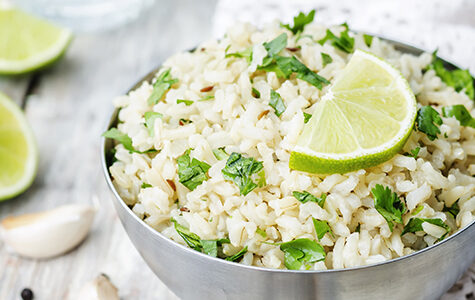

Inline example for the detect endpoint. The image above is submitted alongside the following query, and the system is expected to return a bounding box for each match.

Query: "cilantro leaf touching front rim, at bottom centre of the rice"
[280,239,326,270]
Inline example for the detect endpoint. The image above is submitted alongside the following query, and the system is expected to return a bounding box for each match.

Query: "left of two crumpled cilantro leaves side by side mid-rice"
[177,149,211,191]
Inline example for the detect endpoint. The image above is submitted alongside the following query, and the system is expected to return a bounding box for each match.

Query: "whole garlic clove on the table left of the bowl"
[0,204,96,258]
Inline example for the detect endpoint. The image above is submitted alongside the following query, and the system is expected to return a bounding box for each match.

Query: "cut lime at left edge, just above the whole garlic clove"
[0,93,38,200]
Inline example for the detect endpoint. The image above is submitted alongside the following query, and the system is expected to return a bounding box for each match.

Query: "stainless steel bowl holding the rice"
[101,39,475,300]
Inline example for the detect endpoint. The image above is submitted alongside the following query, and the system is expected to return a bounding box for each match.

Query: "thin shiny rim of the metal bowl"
[100,31,475,275]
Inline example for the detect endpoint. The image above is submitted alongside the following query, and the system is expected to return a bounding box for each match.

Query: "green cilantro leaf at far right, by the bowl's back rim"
[428,50,475,100]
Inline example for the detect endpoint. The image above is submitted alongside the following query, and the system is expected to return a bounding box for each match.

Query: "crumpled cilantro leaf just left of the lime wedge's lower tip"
[221,152,263,196]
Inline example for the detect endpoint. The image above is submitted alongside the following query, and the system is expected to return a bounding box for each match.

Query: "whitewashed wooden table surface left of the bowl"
[0,0,215,300]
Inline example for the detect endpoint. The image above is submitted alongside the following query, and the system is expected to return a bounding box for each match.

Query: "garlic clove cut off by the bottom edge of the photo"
[77,274,119,300]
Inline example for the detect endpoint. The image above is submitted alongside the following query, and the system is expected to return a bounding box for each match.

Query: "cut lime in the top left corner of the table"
[0,9,72,74]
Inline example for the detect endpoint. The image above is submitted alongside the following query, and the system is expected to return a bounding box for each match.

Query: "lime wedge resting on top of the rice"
[289,50,417,174]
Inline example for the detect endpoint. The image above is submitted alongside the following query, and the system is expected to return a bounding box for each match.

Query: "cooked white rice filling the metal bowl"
[110,22,475,270]
